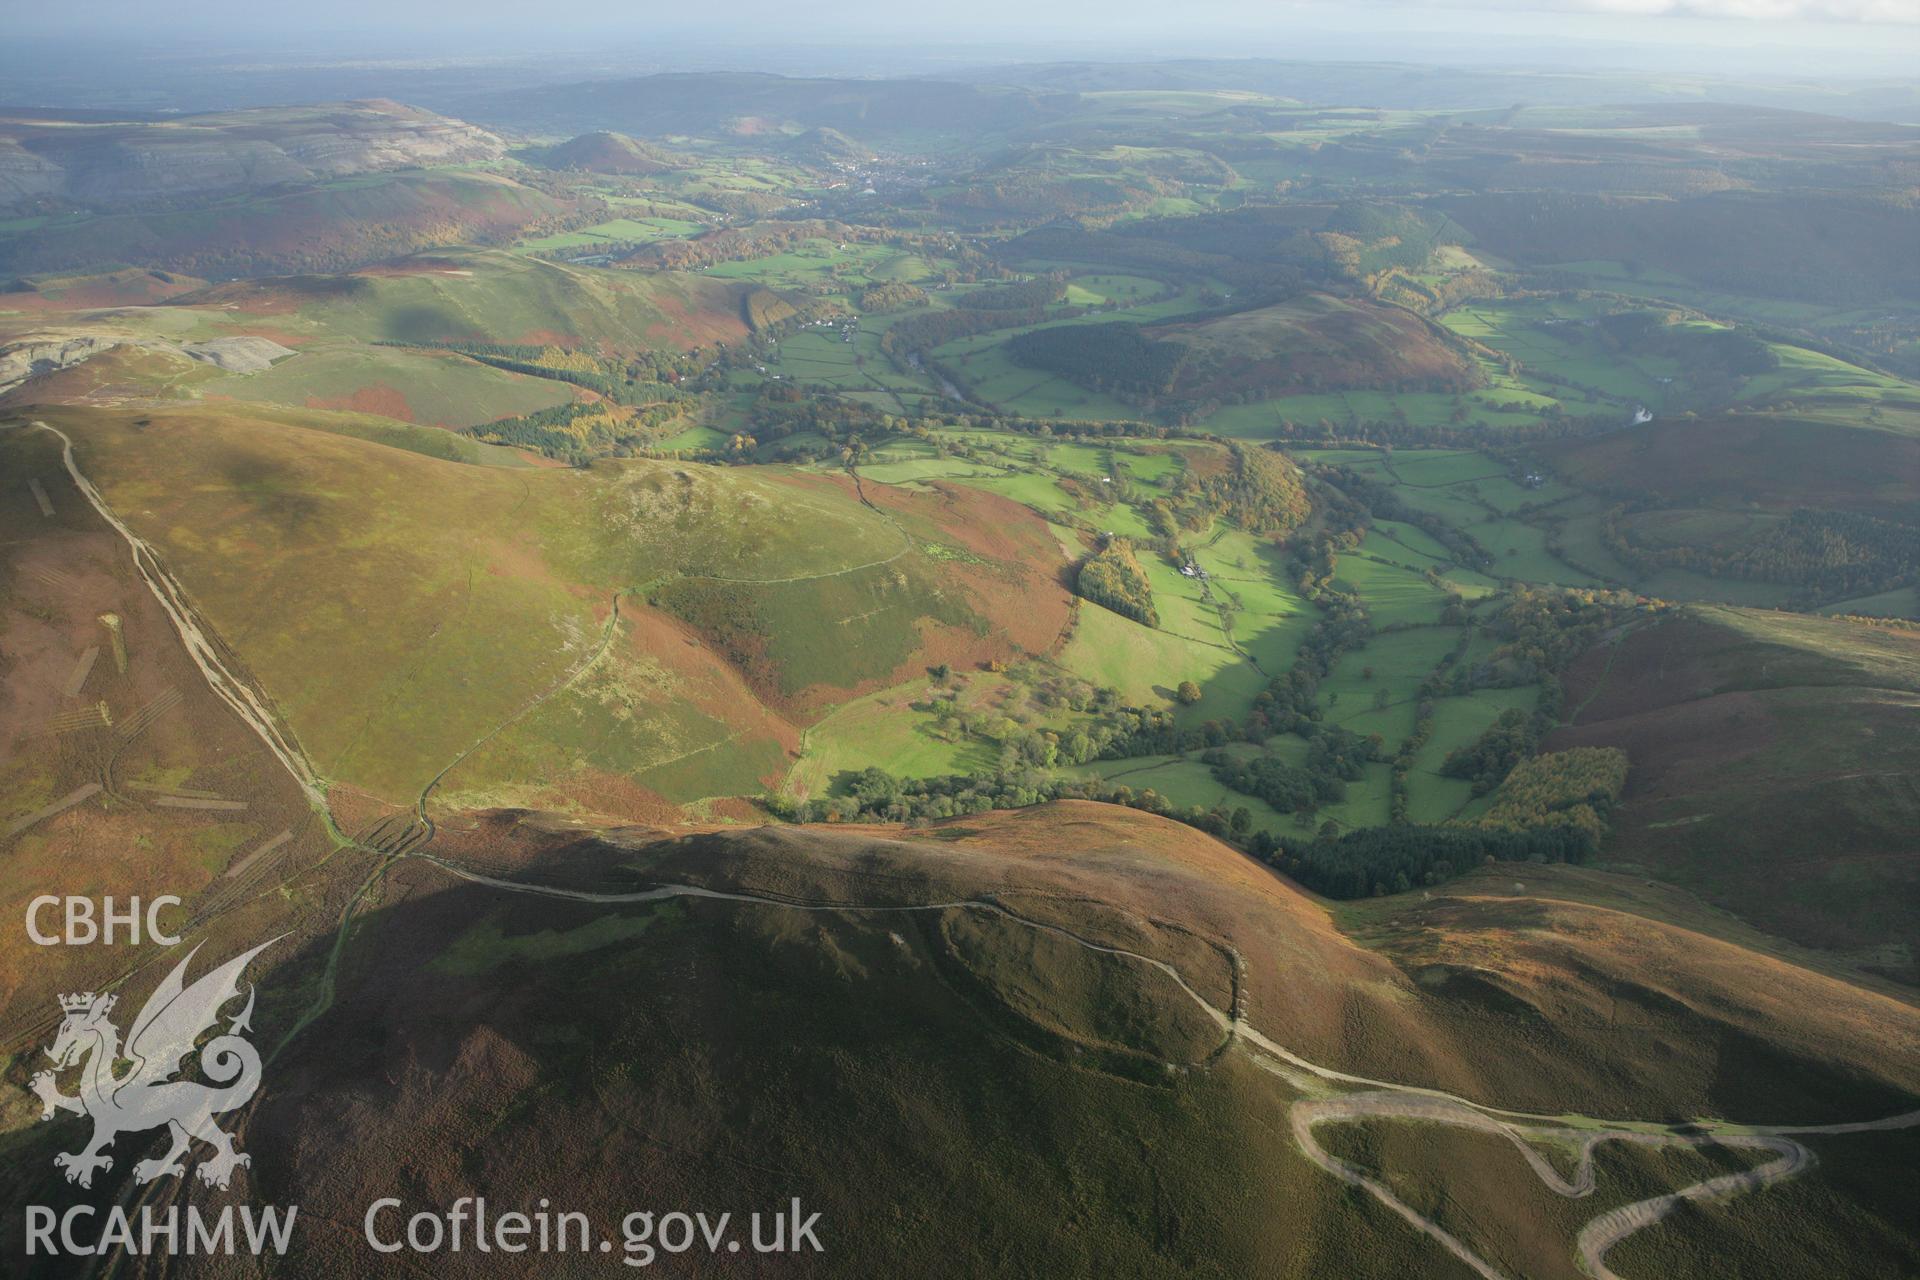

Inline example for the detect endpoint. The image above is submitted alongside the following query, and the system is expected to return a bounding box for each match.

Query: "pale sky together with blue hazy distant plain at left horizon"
[0,0,1920,109]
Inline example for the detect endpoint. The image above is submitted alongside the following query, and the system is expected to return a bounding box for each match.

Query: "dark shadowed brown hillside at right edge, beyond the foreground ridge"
[1549,608,1920,981]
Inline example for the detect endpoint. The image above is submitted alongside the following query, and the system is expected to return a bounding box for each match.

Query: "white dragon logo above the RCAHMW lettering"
[29,938,278,1190]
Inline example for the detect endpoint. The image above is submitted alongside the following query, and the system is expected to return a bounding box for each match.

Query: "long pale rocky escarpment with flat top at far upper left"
[0,100,505,209]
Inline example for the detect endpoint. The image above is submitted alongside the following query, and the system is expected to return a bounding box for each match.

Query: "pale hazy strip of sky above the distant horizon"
[0,0,1920,79]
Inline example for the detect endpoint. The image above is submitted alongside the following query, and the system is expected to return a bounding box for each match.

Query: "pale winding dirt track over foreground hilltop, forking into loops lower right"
[428,854,1920,1280]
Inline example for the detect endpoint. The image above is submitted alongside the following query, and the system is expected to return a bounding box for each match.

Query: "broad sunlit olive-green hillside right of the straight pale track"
[46,407,1066,817]
